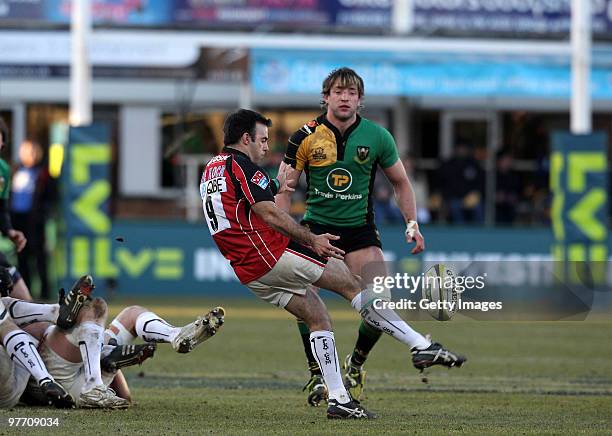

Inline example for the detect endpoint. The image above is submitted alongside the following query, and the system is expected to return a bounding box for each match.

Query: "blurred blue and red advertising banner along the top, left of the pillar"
[0,0,391,29]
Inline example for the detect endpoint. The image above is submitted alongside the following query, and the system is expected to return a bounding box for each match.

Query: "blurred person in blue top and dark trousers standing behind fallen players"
[11,141,56,300]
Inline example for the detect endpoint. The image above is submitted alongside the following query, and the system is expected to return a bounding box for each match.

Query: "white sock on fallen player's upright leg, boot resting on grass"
[73,321,104,392]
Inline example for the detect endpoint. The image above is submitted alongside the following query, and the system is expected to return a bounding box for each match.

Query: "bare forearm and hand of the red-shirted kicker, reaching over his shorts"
[252,201,344,259]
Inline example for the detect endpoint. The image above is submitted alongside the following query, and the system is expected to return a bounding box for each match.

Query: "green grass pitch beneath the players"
[0,297,612,435]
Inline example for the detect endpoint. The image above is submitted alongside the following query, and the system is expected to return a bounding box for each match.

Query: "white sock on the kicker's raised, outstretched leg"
[351,290,431,350]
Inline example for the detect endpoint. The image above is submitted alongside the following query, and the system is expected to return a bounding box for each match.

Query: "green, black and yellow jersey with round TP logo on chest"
[285,114,399,227]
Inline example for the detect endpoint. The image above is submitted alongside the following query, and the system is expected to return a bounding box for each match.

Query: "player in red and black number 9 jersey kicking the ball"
[200,109,465,419]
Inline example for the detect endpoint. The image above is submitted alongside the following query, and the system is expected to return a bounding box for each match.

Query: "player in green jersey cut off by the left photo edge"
[0,118,32,301]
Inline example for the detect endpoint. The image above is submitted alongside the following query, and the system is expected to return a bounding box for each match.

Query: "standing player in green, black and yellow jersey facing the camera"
[276,68,459,406]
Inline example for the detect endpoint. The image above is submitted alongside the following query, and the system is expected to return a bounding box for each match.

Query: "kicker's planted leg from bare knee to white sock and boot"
[285,289,376,419]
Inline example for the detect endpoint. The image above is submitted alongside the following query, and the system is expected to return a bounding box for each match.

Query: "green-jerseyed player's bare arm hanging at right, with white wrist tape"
[383,160,425,254]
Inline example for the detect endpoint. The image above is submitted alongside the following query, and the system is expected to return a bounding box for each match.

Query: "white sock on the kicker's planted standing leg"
[310,330,350,404]
